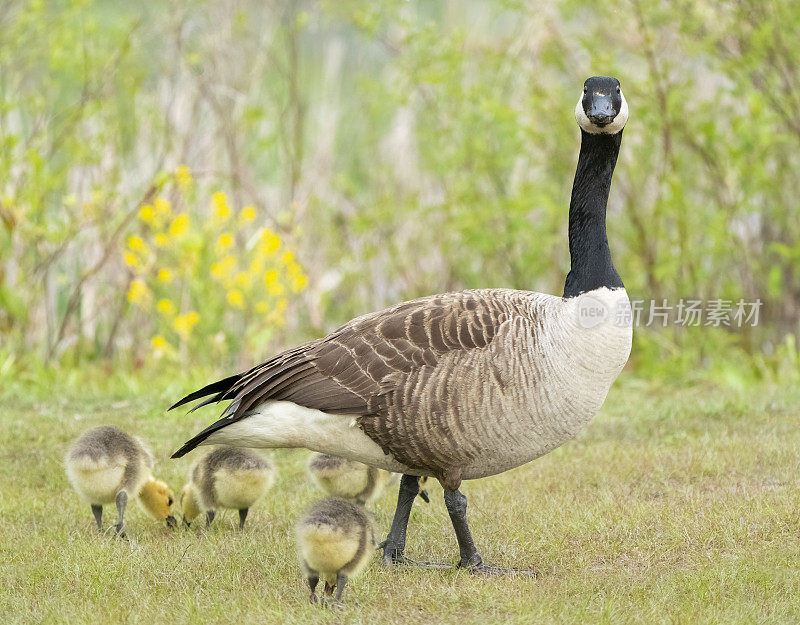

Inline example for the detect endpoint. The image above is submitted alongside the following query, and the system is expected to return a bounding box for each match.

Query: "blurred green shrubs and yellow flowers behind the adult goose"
[0,0,800,386]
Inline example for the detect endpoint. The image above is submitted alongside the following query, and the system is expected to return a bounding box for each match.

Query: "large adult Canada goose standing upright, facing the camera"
[172,77,633,572]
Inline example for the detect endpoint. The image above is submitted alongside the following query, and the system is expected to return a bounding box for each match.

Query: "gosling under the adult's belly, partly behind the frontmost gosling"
[308,454,392,505]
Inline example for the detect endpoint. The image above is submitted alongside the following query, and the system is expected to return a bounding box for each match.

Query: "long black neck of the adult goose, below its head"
[564,129,623,297]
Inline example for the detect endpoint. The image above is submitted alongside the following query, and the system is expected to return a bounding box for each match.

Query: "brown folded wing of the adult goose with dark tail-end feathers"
[176,290,521,453]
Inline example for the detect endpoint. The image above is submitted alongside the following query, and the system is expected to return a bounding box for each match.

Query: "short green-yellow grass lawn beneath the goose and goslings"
[0,372,800,625]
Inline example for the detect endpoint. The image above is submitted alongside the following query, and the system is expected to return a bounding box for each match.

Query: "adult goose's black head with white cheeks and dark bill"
[575,76,628,135]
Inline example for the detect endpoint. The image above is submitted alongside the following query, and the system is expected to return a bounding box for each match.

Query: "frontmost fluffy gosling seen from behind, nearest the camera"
[295,498,375,603]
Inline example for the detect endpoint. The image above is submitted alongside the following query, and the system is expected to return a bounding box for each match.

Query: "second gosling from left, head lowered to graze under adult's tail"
[180,447,275,530]
